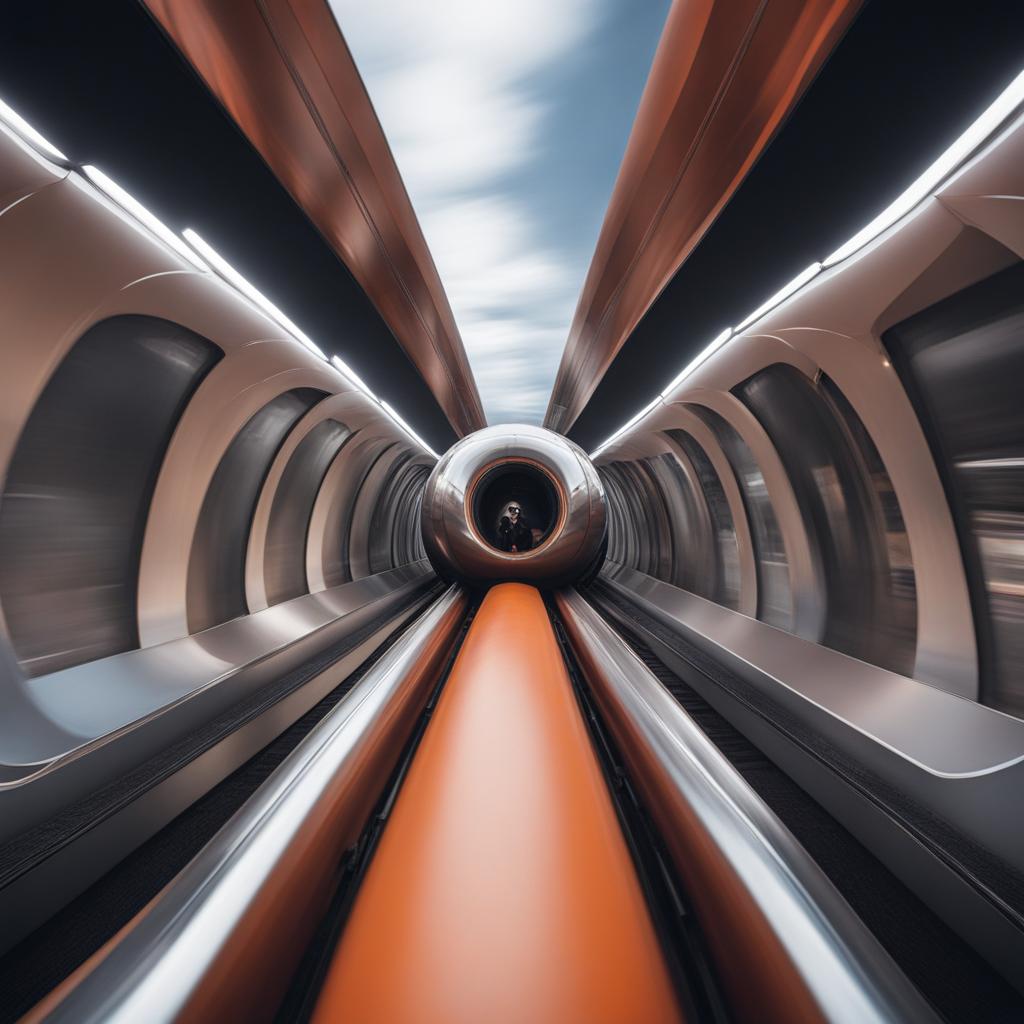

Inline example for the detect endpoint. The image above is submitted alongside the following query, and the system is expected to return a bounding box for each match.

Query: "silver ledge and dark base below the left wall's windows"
[0,562,436,951]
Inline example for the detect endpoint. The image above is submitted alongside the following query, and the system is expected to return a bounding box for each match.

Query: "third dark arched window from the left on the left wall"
[263,420,354,605]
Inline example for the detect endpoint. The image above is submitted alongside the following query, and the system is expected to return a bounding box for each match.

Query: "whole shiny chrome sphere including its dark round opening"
[422,423,606,587]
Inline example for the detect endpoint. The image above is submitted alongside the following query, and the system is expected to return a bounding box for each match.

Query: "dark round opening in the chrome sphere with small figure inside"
[472,460,561,554]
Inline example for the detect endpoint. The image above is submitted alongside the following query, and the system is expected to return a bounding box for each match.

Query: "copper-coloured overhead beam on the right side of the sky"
[544,0,860,433]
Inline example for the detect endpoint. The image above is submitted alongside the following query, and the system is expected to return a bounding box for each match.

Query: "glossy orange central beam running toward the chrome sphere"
[313,584,682,1024]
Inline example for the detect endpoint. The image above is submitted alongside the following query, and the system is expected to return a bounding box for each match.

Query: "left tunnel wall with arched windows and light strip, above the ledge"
[0,128,434,678]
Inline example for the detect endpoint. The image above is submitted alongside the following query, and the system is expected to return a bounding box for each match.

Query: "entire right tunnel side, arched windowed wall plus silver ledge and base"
[594,97,1024,981]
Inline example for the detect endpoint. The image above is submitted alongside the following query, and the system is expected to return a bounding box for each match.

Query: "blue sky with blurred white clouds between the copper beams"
[330,0,670,424]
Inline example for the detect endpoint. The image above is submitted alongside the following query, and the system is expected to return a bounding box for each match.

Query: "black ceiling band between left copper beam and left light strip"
[0,0,456,452]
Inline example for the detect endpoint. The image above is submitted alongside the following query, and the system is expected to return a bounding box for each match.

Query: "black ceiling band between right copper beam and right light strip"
[569,0,1024,451]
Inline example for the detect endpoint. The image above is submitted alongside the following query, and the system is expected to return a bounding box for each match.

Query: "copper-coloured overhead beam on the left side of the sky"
[146,0,486,435]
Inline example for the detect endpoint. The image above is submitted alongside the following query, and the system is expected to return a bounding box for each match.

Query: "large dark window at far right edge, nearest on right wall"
[885,263,1024,716]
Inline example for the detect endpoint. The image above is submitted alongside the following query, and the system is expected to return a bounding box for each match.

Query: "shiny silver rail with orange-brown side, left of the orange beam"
[28,587,465,1024]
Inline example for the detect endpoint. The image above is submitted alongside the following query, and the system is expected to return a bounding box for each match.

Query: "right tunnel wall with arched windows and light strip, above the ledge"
[594,103,1024,716]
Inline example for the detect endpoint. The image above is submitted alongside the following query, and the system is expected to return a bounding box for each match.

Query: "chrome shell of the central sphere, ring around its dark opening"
[422,424,605,585]
